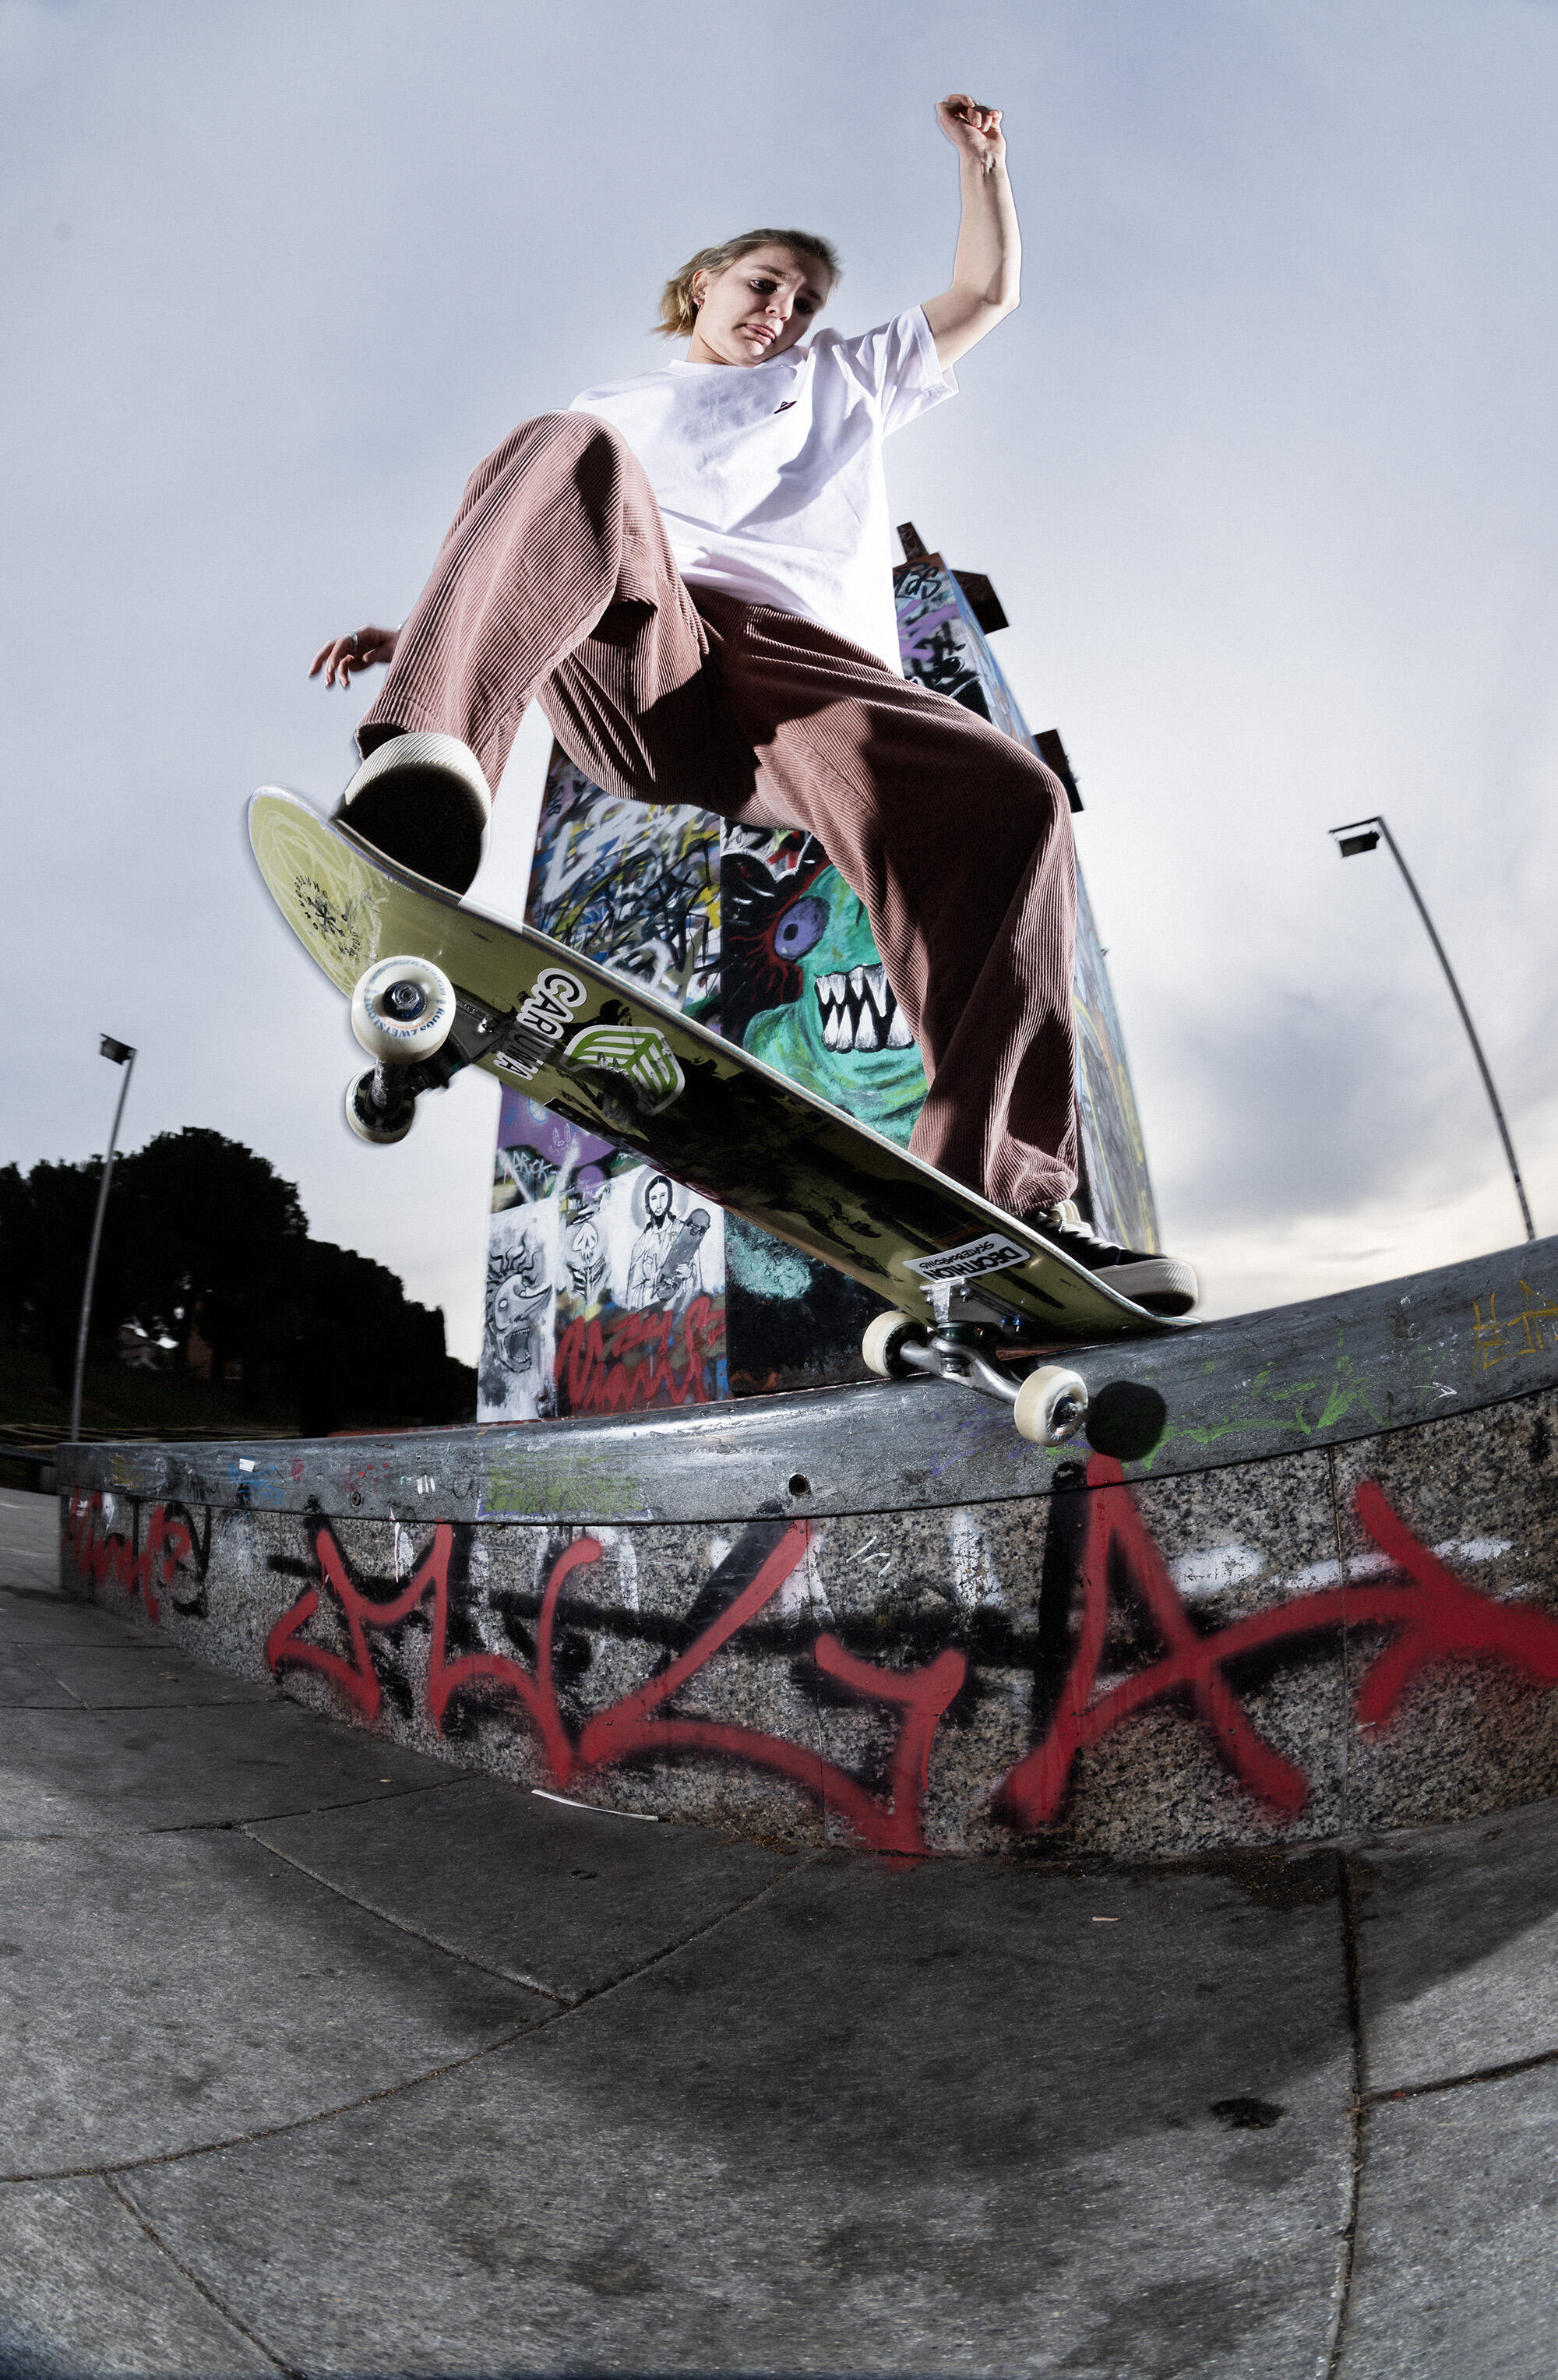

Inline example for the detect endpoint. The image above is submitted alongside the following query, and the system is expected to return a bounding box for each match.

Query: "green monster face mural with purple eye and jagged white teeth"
[721,828,925,1144]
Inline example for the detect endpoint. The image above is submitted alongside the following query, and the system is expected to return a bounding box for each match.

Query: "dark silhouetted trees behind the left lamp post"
[0,1126,476,1435]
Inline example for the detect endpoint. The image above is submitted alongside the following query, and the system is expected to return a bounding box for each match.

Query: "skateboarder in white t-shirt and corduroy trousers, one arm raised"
[309,93,1197,1311]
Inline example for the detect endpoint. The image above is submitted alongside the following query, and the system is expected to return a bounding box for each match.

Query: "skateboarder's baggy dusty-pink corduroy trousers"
[359,414,1077,1214]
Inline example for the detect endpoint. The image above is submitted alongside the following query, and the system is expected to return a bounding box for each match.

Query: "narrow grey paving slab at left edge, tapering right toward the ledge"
[0,1699,461,1837]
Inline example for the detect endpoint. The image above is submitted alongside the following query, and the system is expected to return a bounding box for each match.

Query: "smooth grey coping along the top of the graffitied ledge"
[57,1238,1558,1523]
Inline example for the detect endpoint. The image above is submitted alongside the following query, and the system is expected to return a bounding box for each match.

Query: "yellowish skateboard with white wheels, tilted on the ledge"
[250,785,1183,1444]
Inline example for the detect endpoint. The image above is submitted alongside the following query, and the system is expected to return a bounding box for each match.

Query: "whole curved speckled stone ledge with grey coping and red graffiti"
[51,1240,1558,1856]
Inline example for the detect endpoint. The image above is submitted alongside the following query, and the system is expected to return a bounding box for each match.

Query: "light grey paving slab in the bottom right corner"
[1339,2066,1558,2380]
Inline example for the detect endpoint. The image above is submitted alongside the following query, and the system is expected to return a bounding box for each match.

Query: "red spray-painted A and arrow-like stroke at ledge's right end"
[999,1454,1558,1828]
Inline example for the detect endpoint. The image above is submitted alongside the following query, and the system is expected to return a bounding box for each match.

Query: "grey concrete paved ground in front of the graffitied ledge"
[0,1492,1558,2380]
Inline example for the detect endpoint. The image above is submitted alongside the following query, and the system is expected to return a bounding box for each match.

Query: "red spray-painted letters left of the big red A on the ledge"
[264,1521,968,1852]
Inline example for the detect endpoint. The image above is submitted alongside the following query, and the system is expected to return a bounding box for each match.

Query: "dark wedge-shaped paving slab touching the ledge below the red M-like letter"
[250,1778,818,2001]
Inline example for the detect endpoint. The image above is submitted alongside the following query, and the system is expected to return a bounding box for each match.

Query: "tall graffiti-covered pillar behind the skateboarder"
[481,528,1158,1421]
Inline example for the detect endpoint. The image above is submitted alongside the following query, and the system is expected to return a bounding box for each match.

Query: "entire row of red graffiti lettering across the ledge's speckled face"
[94,1454,1558,1852]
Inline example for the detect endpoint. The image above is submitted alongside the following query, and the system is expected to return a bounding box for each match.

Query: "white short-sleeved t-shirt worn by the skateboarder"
[569,305,959,674]
